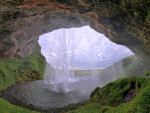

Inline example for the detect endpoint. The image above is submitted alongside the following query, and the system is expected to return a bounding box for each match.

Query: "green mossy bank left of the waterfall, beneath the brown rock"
[0,54,46,91]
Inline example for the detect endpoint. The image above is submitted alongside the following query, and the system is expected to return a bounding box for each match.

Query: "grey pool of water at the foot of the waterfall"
[4,76,103,109]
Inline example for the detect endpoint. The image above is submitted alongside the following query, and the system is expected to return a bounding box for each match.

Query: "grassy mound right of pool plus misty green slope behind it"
[71,55,150,113]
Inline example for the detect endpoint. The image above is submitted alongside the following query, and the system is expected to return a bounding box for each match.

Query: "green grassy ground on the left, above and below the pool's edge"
[0,54,45,113]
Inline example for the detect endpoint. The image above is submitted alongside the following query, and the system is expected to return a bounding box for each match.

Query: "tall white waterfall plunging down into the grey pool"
[44,29,75,92]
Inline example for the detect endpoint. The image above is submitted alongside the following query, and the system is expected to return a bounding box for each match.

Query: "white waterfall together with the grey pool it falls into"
[2,26,133,109]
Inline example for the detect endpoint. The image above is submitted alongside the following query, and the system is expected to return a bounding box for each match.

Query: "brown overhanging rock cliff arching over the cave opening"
[0,0,150,61]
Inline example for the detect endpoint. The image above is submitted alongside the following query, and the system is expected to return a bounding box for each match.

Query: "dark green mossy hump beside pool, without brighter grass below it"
[91,77,150,106]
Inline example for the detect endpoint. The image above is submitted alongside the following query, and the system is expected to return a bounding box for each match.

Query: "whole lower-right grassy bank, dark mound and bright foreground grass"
[70,77,150,113]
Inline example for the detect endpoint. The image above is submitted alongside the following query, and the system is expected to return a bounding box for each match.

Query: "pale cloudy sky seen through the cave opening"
[38,26,133,69]
